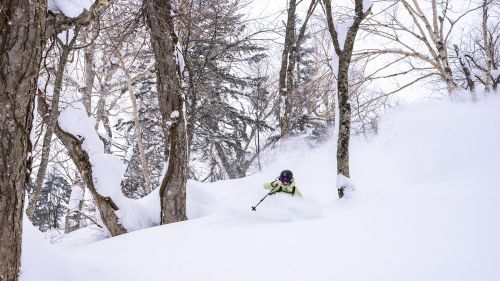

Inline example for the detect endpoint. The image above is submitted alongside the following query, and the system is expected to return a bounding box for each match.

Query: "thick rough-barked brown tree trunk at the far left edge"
[0,0,47,281]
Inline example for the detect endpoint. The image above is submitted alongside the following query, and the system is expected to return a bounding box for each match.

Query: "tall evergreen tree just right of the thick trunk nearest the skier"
[180,0,265,180]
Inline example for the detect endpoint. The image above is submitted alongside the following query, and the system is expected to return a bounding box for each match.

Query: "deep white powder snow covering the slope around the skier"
[21,95,500,281]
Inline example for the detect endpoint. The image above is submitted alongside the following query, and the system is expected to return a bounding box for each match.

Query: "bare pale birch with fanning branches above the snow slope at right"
[356,0,489,96]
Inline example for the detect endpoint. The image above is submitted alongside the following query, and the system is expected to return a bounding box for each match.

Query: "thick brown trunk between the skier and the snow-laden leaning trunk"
[144,0,188,224]
